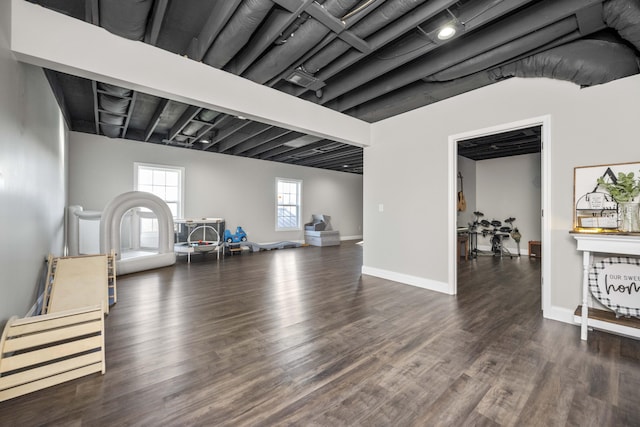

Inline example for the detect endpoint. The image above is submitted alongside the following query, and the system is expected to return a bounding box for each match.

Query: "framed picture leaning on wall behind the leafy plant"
[573,162,640,232]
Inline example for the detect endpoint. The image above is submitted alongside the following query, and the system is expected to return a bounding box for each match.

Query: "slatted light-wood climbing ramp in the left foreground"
[0,304,105,402]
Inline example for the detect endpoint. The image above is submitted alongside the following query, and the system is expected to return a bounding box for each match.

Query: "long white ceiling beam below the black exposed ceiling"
[11,0,370,146]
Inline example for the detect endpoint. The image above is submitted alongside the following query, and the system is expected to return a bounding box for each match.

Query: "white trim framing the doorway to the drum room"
[446,115,553,317]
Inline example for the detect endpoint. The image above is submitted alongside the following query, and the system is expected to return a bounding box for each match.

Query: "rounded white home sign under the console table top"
[589,257,640,318]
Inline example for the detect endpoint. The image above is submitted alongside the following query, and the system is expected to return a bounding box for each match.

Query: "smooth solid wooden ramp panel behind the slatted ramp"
[42,252,117,314]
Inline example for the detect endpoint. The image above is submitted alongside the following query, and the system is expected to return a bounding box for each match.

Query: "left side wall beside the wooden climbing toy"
[0,2,66,325]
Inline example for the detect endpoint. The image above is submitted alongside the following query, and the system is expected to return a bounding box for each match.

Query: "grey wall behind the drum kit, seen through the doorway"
[476,154,542,254]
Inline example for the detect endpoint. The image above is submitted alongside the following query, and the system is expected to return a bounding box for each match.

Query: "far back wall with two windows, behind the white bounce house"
[69,132,362,242]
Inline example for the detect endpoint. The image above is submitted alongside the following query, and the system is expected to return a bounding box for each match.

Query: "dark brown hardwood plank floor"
[0,242,640,426]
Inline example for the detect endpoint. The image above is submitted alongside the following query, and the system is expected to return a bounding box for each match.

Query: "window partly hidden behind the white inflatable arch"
[133,162,184,248]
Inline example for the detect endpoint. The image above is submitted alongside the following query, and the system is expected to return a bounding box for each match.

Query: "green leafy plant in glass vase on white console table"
[598,172,640,232]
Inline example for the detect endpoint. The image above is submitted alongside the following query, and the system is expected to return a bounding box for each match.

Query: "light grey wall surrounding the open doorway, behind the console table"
[363,76,640,319]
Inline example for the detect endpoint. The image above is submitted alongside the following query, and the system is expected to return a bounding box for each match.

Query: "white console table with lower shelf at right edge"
[571,232,640,341]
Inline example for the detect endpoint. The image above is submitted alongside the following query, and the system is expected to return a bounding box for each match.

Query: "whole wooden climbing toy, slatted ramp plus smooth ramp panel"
[0,253,116,401]
